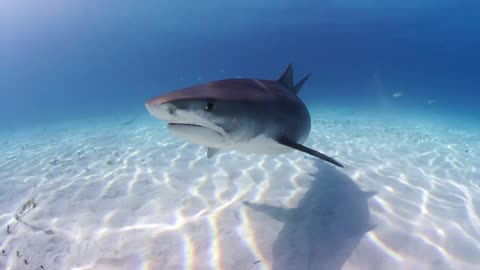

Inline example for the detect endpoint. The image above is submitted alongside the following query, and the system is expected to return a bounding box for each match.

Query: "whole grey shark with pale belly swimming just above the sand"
[145,64,343,167]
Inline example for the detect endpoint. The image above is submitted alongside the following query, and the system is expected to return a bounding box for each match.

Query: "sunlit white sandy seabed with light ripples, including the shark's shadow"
[0,108,480,270]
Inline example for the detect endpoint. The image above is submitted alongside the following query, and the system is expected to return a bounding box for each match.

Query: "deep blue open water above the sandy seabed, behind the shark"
[0,0,480,127]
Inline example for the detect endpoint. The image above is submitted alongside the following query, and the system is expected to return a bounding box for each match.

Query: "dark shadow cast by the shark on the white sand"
[244,162,376,270]
